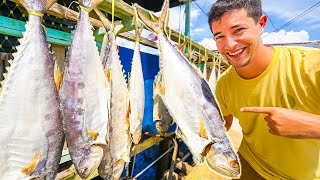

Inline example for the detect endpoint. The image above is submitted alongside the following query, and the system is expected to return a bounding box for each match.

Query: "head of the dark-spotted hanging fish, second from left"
[77,145,103,179]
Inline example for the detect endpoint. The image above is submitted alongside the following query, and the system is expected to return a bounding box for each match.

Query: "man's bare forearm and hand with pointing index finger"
[240,107,320,139]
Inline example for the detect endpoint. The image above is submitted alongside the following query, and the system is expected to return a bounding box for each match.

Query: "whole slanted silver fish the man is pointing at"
[135,0,240,178]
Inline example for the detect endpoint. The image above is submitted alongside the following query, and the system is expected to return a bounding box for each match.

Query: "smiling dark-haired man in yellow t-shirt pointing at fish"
[208,0,320,179]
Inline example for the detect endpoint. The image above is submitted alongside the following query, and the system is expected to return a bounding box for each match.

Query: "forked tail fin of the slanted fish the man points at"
[134,0,169,32]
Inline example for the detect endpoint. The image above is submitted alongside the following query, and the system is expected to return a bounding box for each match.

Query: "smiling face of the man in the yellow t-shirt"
[211,9,266,68]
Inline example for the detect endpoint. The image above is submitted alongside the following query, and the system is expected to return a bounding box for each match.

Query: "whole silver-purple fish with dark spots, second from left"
[60,0,110,178]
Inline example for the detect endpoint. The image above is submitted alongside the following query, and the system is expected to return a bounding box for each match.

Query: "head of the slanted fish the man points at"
[205,143,241,179]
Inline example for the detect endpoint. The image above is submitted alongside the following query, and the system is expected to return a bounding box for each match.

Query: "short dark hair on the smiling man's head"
[208,0,262,31]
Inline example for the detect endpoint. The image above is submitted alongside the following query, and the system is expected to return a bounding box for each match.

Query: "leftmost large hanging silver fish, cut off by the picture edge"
[0,0,63,179]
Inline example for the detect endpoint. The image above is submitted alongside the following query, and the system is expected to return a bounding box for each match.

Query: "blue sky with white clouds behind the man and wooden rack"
[118,0,320,54]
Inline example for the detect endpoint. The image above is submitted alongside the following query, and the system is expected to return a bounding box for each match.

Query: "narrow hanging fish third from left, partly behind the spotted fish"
[96,7,131,179]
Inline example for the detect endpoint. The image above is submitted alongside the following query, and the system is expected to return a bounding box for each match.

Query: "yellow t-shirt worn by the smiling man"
[216,47,320,179]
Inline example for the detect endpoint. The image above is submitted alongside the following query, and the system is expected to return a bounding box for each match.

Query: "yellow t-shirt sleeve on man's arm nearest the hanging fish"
[215,79,230,116]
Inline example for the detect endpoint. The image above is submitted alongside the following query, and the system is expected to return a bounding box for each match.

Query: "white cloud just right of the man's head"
[262,30,309,44]
